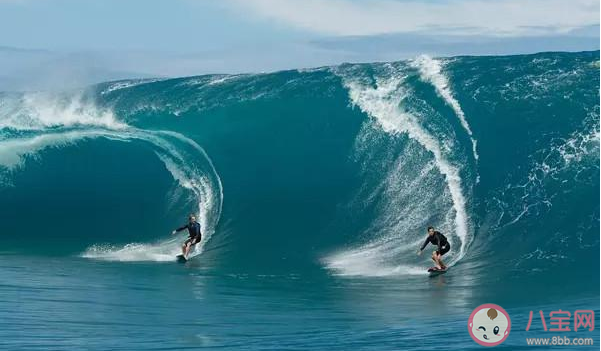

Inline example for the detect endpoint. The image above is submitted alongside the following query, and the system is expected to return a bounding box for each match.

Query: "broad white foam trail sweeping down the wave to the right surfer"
[325,65,471,276]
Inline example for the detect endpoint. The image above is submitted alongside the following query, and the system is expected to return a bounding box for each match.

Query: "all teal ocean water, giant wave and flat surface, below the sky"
[0,51,600,350]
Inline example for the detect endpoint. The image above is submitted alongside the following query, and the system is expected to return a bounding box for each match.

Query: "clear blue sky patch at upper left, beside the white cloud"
[0,0,314,52]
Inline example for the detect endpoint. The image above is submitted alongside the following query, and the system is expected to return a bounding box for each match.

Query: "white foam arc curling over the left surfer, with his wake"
[0,94,223,261]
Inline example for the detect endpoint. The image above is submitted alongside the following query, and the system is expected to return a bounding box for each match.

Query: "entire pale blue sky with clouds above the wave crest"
[0,0,599,88]
